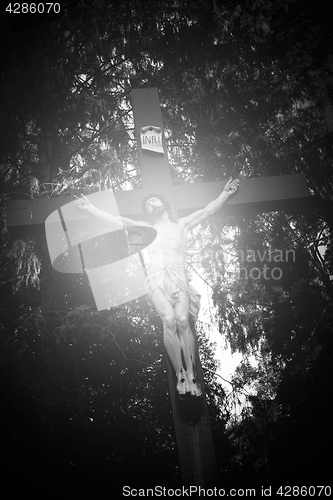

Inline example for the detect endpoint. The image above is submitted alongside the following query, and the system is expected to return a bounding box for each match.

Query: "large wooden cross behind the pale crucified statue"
[7,88,309,487]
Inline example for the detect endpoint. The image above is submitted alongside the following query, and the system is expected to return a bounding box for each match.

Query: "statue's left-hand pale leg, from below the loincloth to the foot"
[152,288,188,395]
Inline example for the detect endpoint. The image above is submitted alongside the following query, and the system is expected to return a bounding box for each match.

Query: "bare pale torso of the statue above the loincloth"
[147,222,187,268]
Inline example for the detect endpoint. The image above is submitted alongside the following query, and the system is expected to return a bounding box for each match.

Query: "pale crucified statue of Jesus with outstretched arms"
[76,179,239,397]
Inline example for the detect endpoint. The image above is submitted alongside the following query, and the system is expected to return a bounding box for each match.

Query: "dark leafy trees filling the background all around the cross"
[0,0,333,490]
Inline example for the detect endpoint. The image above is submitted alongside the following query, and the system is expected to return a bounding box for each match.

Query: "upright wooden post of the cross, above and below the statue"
[132,88,218,488]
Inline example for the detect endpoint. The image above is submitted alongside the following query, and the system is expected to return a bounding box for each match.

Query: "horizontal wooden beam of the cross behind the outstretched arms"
[7,174,310,238]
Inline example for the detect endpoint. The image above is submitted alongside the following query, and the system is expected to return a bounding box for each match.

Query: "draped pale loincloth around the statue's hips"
[146,267,200,321]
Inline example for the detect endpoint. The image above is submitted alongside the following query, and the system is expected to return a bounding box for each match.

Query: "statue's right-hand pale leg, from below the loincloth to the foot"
[174,291,202,396]
